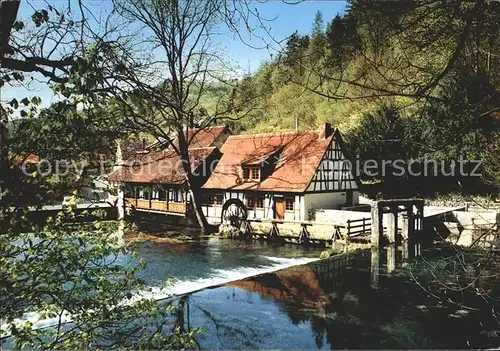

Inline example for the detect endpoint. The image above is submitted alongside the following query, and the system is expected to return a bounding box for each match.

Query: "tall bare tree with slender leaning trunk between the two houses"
[86,0,264,231]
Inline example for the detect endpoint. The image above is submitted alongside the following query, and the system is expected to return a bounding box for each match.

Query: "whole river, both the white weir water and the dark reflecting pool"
[3,232,500,349]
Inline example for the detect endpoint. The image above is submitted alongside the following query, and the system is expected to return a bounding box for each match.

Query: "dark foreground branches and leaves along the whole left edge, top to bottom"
[0,5,201,349]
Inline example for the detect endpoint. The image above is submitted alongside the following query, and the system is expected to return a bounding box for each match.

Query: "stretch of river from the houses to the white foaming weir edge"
[128,238,321,298]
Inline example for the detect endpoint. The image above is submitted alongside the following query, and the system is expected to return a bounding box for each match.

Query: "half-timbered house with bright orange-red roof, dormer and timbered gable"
[203,124,359,222]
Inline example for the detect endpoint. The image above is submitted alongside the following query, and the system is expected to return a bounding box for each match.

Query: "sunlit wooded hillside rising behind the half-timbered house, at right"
[225,0,500,195]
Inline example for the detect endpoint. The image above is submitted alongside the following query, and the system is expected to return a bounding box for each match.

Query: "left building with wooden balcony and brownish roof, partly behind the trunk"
[109,127,229,216]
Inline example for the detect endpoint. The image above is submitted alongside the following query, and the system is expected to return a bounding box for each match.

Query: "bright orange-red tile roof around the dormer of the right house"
[203,131,335,192]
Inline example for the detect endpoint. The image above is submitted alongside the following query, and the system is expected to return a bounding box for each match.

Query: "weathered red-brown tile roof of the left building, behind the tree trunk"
[109,147,217,184]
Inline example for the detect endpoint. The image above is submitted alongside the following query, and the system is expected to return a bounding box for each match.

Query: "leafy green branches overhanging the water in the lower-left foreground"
[0,212,199,349]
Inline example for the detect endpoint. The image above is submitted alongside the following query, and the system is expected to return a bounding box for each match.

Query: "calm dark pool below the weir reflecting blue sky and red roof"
[168,252,500,349]
